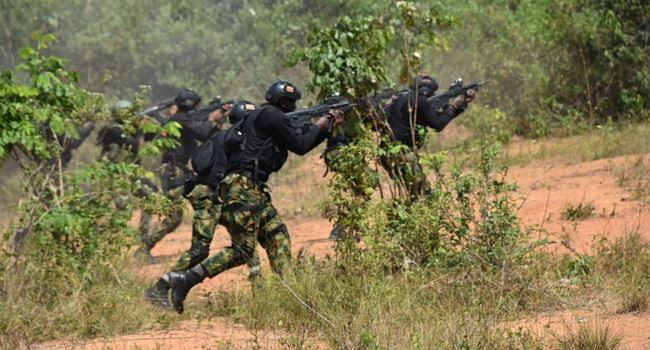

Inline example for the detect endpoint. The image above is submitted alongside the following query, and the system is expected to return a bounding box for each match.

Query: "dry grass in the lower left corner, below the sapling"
[0,260,179,349]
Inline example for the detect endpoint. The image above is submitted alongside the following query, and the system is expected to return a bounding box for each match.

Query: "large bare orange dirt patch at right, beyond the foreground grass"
[509,155,650,253]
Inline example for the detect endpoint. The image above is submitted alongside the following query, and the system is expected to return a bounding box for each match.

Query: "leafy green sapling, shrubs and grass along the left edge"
[0,36,179,347]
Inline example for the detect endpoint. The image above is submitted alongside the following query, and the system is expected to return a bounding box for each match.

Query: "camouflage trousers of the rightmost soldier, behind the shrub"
[380,147,431,200]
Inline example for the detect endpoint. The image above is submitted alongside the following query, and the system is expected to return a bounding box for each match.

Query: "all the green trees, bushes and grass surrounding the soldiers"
[0,0,650,349]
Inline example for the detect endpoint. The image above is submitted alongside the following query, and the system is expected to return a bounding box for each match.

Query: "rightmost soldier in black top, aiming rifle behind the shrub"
[381,75,476,200]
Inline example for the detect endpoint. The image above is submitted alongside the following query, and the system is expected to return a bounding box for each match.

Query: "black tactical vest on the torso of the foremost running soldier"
[228,106,289,182]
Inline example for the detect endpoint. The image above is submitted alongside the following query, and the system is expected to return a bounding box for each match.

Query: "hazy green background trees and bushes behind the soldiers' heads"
[0,0,650,136]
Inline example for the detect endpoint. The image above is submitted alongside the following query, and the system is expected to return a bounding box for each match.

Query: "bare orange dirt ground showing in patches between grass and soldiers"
[37,154,650,349]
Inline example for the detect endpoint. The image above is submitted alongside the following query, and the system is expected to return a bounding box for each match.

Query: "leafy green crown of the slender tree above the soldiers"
[290,1,455,99]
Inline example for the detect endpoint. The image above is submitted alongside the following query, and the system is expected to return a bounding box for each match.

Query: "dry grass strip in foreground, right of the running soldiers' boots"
[177,233,650,349]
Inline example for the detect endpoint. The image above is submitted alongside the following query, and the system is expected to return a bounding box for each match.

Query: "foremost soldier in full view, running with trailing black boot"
[170,80,343,313]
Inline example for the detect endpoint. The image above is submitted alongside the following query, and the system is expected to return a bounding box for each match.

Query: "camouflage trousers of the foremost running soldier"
[201,174,291,278]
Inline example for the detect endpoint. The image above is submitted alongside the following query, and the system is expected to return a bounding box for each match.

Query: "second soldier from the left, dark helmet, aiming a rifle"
[137,89,223,262]
